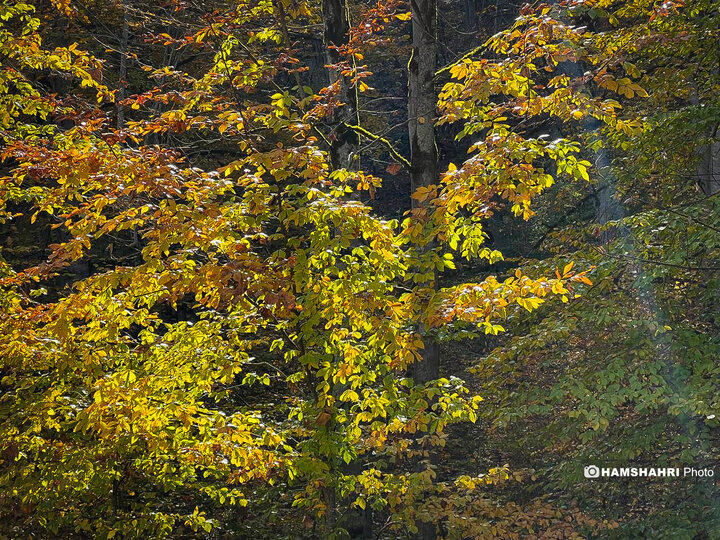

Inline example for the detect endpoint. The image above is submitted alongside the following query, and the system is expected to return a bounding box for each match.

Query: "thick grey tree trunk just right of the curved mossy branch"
[408,0,440,540]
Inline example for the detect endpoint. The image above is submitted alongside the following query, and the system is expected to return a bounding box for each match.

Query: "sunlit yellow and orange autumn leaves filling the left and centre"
[0,0,718,538]
